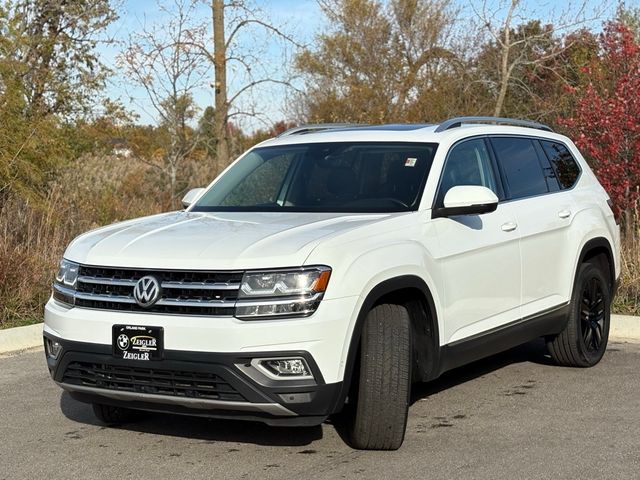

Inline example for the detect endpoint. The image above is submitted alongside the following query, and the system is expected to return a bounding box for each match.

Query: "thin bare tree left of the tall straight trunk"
[118,0,209,208]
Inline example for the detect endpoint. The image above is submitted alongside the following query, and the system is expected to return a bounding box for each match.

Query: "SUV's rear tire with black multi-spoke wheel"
[547,263,611,368]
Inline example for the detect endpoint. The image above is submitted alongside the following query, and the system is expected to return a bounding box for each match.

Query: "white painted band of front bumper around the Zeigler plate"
[44,297,358,383]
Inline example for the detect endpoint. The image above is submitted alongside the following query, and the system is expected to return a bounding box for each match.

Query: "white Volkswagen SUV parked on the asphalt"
[44,117,620,449]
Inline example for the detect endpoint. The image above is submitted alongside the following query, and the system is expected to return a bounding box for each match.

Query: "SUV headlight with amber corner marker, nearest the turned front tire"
[236,266,331,319]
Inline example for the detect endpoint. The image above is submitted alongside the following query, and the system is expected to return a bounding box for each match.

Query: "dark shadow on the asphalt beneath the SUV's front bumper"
[60,392,322,447]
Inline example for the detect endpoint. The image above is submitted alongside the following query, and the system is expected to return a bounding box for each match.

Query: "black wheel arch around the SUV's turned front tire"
[334,275,440,411]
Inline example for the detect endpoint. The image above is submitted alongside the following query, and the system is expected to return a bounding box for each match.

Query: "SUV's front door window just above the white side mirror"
[436,139,499,206]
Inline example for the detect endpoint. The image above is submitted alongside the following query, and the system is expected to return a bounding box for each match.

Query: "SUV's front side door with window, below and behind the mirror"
[433,138,521,343]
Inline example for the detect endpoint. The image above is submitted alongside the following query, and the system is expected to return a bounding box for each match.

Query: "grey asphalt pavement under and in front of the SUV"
[0,343,640,480]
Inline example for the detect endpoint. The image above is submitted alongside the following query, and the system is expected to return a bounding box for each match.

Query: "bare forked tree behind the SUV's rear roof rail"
[470,0,606,117]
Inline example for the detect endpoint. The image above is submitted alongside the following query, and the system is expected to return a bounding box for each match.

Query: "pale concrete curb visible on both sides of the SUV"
[0,315,640,354]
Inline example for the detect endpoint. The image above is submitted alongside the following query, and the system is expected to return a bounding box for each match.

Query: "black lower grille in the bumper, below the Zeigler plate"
[62,362,246,402]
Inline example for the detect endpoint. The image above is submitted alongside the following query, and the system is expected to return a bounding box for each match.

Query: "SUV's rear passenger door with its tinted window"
[491,136,577,318]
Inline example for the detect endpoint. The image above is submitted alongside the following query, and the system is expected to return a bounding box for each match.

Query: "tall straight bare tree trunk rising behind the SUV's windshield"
[211,0,229,174]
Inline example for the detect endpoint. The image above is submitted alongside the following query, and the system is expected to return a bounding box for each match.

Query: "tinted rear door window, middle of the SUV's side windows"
[491,137,549,199]
